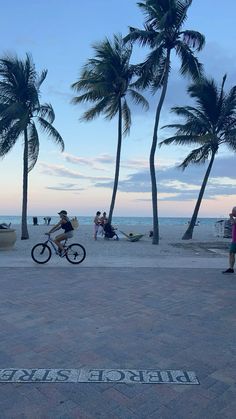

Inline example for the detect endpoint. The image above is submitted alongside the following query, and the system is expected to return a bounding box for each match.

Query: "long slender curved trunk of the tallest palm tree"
[149,51,170,244]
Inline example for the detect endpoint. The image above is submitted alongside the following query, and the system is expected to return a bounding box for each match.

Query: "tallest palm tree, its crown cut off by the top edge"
[125,0,205,244]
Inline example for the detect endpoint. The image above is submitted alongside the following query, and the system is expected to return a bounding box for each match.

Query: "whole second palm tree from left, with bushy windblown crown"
[72,35,148,223]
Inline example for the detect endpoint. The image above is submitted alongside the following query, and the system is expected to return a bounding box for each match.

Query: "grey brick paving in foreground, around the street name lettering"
[0,267,236,419]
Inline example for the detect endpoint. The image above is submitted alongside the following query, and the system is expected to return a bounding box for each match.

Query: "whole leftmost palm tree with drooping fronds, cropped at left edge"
[0,54,64,240]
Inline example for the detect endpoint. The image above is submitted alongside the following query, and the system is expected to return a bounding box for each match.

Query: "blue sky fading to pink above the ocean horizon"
[0,0,236,217]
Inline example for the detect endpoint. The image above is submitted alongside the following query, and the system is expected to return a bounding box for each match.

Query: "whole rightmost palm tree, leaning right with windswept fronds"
[160,76,236,240]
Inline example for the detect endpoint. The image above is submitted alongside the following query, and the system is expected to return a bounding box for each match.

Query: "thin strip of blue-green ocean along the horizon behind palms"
[0,214,219,226]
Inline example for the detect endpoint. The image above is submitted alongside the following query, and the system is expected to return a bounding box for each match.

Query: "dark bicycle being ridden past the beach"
[31,234,86,265]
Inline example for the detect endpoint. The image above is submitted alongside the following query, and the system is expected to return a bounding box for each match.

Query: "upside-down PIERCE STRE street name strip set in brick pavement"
[0,368,199,384]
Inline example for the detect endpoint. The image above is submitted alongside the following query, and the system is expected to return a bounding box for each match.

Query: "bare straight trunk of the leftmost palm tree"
[21,128,29,240]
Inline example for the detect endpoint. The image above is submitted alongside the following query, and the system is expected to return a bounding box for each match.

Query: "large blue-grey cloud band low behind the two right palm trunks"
[95,156,236,201]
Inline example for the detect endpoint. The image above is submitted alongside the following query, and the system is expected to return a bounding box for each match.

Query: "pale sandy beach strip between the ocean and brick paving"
[0,223,230,269]
